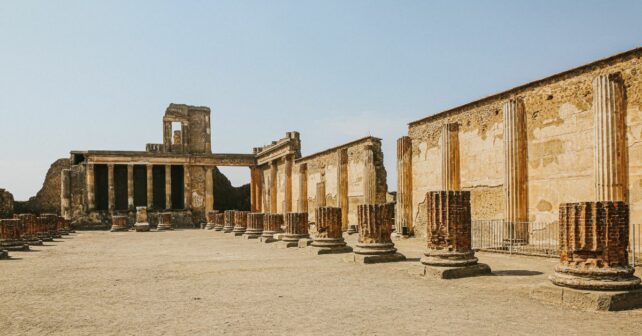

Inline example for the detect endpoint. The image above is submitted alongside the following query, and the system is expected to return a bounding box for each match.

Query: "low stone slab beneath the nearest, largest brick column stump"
[530,283,642,311]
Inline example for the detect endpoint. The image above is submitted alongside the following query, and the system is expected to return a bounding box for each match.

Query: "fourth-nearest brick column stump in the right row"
[310,207,352,254]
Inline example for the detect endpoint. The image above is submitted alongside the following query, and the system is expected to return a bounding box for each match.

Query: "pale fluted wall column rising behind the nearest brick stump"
[593,73,627,201]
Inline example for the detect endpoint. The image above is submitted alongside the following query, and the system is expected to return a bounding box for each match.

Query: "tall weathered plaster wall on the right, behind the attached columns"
[409,49,642,240]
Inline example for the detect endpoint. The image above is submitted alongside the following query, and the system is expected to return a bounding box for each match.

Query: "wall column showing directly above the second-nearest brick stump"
[441,124,460,191]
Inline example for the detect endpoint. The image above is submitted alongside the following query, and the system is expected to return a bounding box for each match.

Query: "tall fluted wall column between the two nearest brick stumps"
[504,98,528,244]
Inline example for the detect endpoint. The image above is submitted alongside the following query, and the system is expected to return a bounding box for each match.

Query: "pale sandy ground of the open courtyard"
[0,230,642,335]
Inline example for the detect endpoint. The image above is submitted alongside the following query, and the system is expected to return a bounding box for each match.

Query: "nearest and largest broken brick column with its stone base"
[531,201,642,310]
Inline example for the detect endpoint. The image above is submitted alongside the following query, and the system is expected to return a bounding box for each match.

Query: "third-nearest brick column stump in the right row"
[348,203,406,264]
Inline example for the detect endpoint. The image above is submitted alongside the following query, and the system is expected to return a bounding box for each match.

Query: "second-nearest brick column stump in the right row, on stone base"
[421,190,490,279]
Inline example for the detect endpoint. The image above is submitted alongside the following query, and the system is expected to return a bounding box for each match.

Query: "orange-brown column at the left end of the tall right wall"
[395,136,413,236]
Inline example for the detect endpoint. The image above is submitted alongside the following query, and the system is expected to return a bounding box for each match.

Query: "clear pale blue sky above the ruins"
[0,0,642,200]
